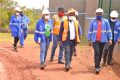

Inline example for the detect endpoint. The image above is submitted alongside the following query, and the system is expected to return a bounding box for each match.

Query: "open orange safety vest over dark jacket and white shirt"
[62,19,80,42]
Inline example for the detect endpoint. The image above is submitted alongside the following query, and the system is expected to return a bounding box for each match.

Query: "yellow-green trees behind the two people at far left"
[0,0,41,30]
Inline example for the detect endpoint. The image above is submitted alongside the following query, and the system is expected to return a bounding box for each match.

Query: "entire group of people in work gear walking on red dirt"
[10,7,120,74]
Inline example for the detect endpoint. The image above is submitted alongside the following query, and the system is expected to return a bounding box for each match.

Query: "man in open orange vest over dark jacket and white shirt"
[59,8,81,71]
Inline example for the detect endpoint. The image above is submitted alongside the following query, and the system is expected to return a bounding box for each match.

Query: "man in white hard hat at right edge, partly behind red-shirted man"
[103,10,120,66]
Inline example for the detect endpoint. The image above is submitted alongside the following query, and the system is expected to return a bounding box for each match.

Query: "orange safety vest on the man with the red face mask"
[53,14,65,35]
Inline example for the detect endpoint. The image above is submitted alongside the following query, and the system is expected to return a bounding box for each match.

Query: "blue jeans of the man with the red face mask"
[50,35,64,62]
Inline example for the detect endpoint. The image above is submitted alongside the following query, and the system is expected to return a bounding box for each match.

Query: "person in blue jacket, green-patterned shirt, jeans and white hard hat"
[34,9,53,69]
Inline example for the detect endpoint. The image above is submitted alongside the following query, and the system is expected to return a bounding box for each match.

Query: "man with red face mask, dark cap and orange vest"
[50,7,65,64]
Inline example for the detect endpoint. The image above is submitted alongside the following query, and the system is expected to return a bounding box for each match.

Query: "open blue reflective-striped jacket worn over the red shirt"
[87,18,112,42]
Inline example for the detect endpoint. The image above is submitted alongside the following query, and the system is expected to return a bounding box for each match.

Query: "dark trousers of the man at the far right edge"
[103,42,115,63]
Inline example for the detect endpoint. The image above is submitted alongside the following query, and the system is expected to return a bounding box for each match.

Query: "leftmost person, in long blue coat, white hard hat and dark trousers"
[9,7,22,52]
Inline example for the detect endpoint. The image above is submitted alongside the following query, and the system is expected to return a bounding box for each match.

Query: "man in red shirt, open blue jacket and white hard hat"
[87,8,112,74]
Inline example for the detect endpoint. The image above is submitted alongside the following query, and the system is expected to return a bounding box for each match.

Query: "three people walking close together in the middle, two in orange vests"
[34,7,82,71]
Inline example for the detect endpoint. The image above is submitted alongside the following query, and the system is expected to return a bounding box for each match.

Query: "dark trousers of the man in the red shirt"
[93,42,105,68]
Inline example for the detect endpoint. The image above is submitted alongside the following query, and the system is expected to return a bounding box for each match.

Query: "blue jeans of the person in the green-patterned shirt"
[40,38,50,64]
